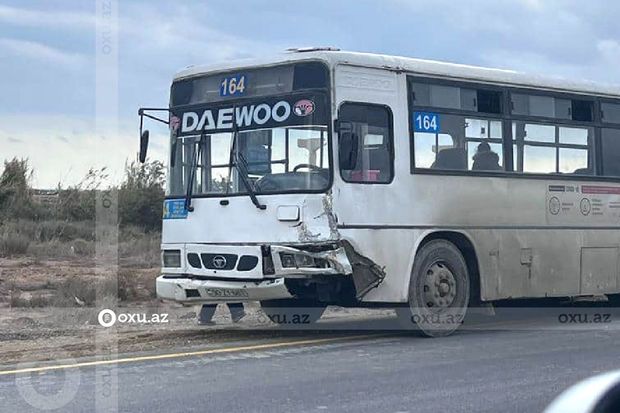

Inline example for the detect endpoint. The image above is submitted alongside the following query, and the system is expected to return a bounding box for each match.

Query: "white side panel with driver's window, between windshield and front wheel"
[332,66,414,302]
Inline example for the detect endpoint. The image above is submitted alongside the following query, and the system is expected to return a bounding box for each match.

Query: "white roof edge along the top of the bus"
[175,48,620,98]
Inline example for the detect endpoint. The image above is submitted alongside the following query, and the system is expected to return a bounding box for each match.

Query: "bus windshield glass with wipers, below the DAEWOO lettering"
[168,125,331,196]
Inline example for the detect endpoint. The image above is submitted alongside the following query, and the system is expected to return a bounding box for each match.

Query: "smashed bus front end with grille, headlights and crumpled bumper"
[157,241,385,303]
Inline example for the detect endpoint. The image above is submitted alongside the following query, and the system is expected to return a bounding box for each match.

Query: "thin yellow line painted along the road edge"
[0,334,381,376]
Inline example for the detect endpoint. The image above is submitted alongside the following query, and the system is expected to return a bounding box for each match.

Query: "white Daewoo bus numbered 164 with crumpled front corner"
[140,48,620,336]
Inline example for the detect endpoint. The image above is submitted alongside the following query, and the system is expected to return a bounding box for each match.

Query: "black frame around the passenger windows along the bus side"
[406,73,620,182]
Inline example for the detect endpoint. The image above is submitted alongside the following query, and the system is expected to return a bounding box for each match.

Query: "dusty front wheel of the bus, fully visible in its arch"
[396,240,471,337]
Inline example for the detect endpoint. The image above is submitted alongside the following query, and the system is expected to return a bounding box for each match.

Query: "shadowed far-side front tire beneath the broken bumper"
[260,299,326,325]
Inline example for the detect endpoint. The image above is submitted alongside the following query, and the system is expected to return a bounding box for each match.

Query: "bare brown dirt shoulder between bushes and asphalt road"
[0,258,392,365]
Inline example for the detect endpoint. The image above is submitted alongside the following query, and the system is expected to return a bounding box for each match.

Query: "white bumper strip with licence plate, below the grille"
[156,274,293,304]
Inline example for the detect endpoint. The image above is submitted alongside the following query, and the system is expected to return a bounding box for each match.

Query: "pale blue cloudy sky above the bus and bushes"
[0,0,620,187]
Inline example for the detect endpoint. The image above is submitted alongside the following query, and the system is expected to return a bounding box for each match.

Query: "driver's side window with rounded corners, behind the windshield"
[339,103,394,184]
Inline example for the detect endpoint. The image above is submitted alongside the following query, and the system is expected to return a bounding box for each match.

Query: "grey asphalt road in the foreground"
[0,308,620,413]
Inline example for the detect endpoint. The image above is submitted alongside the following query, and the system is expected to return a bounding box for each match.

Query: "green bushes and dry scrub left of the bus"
[0,158,165,260]
